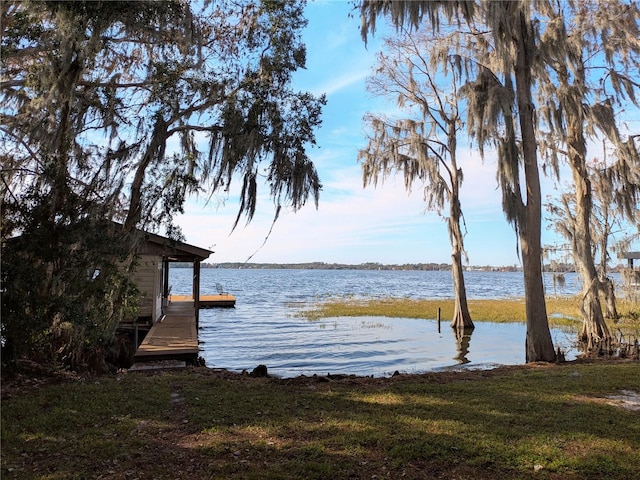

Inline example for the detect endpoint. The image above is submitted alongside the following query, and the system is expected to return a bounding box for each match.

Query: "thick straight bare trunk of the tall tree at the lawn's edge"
[514,10,556,362]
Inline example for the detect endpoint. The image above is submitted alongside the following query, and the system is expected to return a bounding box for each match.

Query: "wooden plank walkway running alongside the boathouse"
[133,301,198,362]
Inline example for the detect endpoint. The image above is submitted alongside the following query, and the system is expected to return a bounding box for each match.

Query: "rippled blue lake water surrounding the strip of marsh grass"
[169,268,592,377]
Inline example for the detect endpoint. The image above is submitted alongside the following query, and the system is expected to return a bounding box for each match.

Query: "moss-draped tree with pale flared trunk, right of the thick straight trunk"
[538,0,640,348]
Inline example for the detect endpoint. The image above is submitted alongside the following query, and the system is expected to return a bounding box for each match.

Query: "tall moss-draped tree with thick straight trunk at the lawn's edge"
[360,0,555,362]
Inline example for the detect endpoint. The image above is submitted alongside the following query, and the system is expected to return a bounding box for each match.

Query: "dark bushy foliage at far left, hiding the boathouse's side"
[2,187,137,369]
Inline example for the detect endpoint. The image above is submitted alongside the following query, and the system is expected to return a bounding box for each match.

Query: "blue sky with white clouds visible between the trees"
[176,0,640,266]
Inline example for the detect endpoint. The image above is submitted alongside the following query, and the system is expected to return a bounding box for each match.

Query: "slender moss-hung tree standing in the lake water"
[359,30,474,329]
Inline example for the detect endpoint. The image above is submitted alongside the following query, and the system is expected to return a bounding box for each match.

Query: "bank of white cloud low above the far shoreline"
[178,143,512,263]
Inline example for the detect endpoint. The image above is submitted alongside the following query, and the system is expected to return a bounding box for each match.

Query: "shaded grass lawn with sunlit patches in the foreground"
[1,361,640,480]
